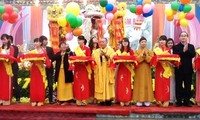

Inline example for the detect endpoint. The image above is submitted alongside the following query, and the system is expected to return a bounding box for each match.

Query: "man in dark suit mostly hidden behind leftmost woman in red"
[9,35,20,103]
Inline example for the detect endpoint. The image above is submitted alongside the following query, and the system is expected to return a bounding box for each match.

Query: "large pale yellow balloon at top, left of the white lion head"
[66,2,80,16]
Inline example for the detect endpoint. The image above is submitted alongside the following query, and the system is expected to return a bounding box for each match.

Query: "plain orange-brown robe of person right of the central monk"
[133,48,154,102]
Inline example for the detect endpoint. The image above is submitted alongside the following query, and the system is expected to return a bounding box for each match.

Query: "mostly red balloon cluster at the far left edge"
[0,5,19,24]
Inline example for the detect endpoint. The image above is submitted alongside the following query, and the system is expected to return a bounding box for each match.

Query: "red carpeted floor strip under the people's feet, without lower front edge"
[0,103,200,116]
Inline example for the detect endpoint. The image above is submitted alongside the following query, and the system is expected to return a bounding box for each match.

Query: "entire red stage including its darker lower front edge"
[0,103,200,120]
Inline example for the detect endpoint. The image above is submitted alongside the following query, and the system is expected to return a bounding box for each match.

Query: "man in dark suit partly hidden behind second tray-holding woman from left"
[39,35,54,104]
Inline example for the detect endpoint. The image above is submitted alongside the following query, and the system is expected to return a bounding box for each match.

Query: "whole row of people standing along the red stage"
[0,31,200,107]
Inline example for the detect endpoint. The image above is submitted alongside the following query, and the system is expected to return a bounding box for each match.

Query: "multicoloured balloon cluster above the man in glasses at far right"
[165,0,194,27]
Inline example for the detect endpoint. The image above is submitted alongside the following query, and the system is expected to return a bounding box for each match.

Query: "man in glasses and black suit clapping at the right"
[173,32,196,107]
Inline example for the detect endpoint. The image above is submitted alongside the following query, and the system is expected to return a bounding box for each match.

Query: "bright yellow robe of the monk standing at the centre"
[92,47,115,101]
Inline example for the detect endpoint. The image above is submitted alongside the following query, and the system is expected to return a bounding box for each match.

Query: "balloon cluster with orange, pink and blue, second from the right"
[130,0,155,17]
